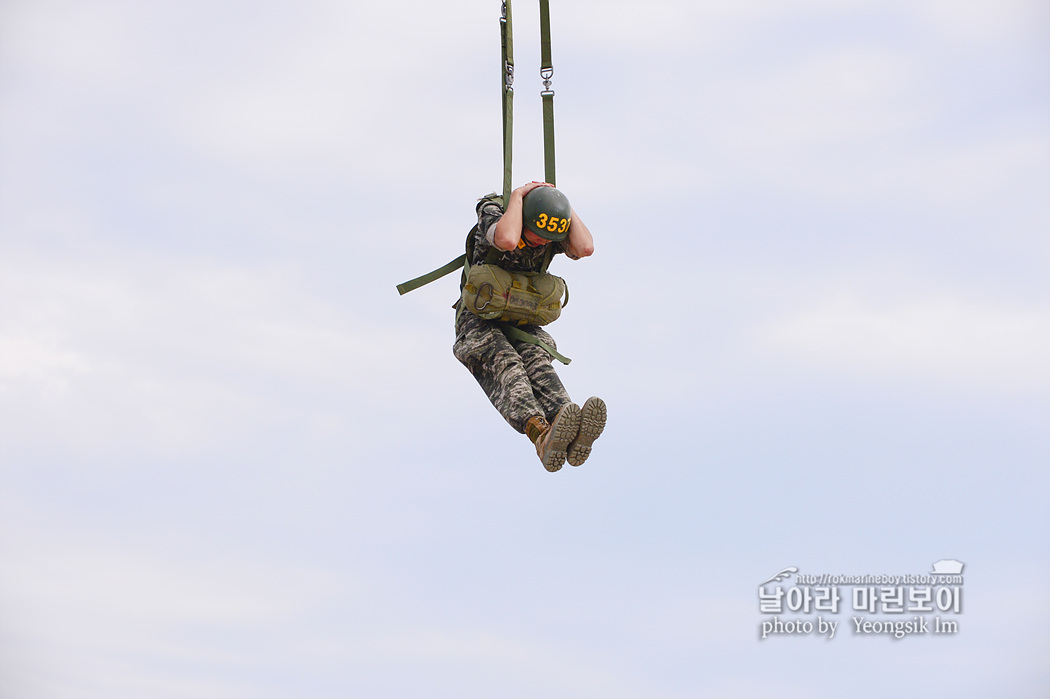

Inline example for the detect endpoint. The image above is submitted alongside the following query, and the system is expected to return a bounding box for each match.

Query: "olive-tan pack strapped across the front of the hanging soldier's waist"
[462,264,569,325]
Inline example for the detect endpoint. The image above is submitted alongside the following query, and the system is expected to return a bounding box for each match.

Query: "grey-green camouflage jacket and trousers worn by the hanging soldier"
[453,193,572,433]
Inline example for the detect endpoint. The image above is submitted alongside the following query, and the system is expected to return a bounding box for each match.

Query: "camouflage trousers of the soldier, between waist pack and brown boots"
[453,311,572,433]
